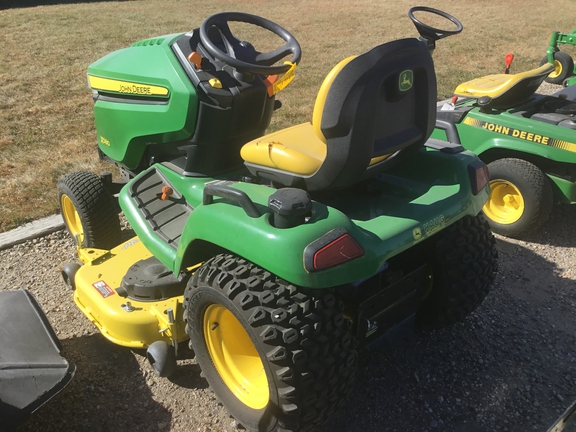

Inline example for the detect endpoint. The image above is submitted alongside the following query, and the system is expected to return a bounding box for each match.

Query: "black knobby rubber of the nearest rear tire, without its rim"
[184,254,357,431]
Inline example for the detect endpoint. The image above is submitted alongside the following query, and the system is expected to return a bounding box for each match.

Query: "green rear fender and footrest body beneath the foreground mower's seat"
[120,149,488,288]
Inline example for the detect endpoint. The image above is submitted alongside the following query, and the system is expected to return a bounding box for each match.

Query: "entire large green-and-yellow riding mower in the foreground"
[58,8,497,431]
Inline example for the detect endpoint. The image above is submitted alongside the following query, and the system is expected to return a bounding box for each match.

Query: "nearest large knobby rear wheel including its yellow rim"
[184,255,357,432]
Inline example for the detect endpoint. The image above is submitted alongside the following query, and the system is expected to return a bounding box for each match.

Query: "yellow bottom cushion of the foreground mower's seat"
[240,123,326,176]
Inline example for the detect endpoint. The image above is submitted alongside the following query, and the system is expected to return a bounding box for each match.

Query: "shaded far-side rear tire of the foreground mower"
[416,214,498,329]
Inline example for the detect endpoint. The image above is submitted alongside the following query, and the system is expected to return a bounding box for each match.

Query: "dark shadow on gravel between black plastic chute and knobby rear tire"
[18,334,172,432]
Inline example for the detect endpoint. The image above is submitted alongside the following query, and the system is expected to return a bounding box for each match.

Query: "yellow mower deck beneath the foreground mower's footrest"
[74,237,188,348]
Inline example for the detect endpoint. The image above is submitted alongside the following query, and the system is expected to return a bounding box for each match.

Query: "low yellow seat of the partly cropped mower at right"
[454,63,554,109]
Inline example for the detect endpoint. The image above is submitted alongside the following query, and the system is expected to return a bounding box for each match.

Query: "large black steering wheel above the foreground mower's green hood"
[200,12,302,75]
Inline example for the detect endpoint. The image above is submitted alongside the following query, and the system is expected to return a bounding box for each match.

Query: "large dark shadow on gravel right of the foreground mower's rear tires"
[321,226,576,432]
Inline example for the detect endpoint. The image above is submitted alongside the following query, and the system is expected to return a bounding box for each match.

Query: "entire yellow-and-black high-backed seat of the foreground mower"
[241,39,436,191]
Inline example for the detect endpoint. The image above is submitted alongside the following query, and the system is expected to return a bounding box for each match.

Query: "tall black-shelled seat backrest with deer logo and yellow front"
[305,39,437,190]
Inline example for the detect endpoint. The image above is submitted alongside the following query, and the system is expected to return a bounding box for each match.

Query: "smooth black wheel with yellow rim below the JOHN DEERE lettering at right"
[482,158,554,238]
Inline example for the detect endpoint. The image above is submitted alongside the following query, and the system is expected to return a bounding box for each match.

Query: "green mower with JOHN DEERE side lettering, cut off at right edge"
[432,48,576,238]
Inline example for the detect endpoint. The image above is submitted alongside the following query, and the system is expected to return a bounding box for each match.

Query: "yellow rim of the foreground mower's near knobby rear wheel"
[203,304,270,409]
